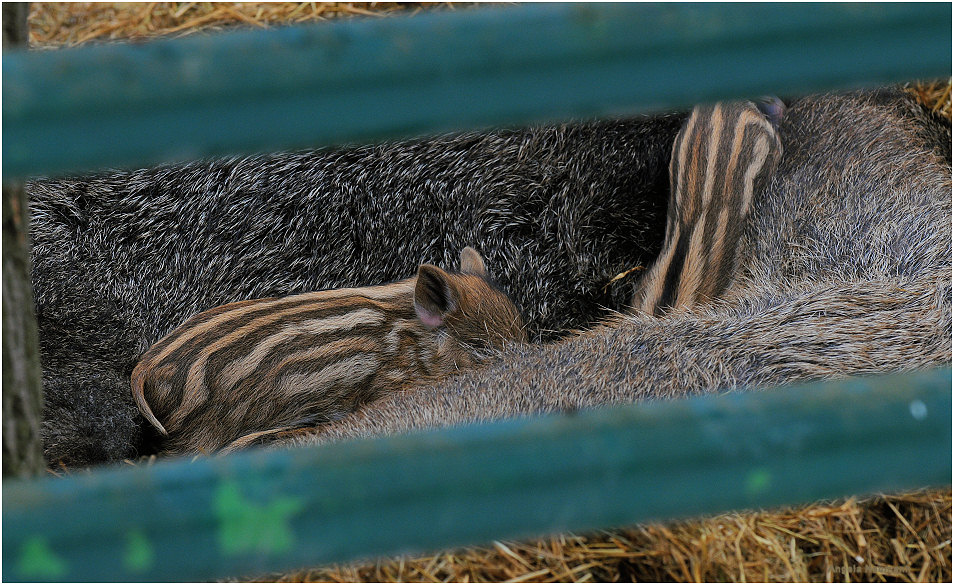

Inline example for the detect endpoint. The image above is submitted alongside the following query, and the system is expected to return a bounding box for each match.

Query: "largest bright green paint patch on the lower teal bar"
[215,482,304,555]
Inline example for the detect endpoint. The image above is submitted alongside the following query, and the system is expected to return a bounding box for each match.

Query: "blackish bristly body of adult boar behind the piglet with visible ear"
[27,115,684,465]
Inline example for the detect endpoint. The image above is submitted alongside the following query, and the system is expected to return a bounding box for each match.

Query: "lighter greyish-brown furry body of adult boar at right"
[268,91,952,444]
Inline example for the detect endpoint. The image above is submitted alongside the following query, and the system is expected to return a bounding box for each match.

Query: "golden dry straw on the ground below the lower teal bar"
[236,489,951,583]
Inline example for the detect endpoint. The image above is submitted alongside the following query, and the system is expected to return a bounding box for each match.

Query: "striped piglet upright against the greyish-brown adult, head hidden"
[633,102,782,316]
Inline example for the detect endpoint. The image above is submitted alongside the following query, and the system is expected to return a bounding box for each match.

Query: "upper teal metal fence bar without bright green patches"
[3,3,951,179]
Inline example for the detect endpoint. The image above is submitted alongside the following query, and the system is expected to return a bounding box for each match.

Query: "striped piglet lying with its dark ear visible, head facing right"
[131,248,526,453]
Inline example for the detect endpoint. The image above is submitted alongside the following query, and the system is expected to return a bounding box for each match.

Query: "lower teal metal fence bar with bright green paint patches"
[3,369,952,581]
